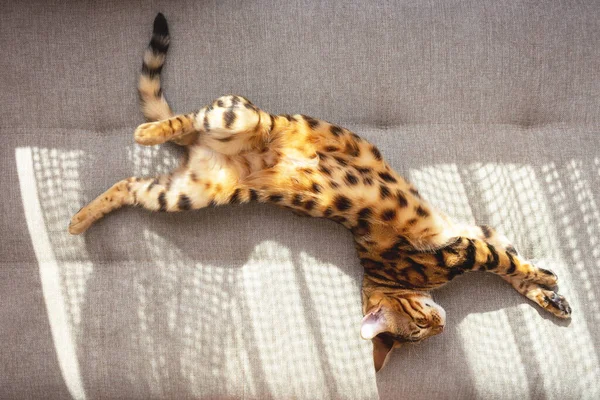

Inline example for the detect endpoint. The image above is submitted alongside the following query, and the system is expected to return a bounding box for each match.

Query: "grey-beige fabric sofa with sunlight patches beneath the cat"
[0,0,600,399]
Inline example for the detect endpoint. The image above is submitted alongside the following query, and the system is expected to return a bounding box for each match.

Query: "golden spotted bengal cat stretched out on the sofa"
[69,14,571,370]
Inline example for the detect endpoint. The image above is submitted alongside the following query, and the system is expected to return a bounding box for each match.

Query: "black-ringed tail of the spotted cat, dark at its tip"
[138,13,173,121]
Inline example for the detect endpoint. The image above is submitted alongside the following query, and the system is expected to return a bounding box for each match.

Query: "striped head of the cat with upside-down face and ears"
[360,291,446,371]
